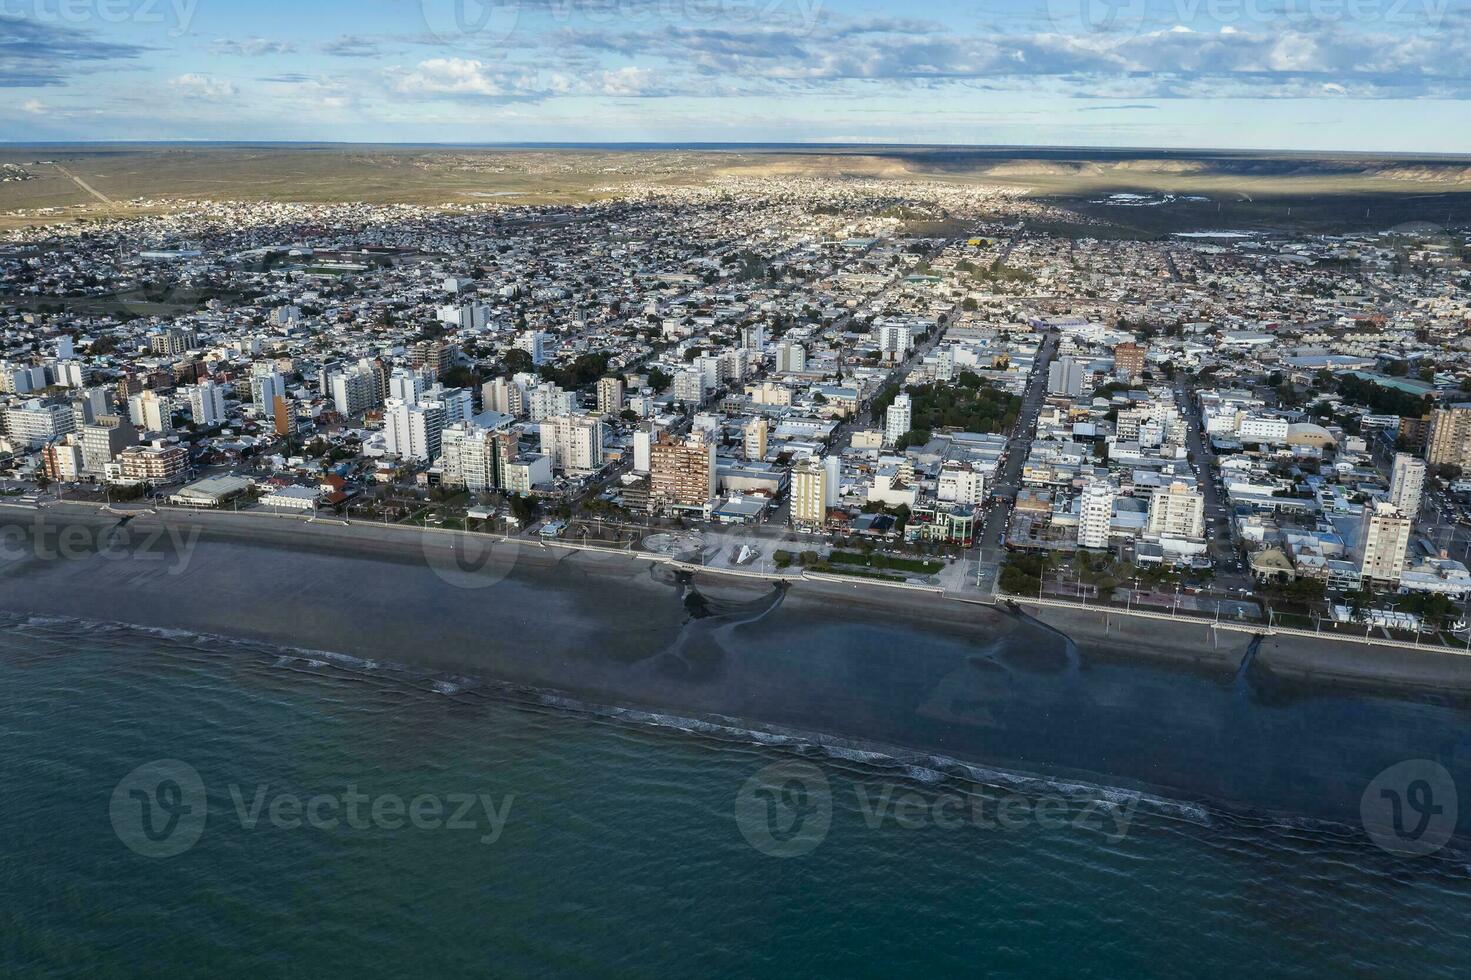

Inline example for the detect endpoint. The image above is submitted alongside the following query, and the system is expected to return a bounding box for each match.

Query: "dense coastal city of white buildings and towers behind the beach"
[0,143,1471,632]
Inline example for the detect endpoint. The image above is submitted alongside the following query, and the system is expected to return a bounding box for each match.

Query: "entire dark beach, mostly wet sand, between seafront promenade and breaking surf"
[0,511,1471,821]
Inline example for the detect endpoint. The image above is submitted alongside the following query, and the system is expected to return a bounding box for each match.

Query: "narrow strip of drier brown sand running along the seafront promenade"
[11,503,1471,696]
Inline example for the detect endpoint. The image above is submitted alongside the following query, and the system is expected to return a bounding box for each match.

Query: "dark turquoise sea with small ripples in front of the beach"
[0,618,1471,977]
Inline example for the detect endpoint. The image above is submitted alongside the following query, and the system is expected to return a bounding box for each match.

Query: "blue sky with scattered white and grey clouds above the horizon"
[0,0,1471,153]
